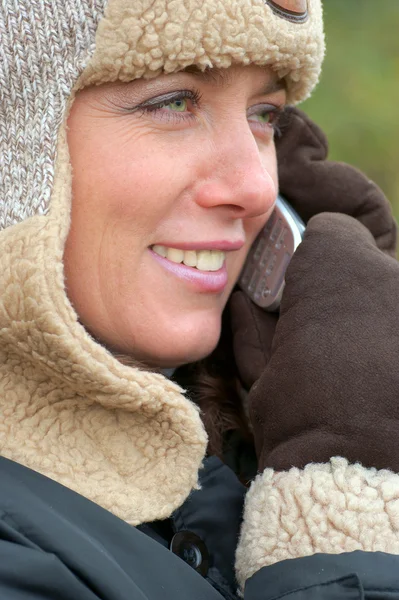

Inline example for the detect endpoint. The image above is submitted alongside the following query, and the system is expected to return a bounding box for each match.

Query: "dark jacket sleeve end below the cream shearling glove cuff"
[244,551,399,600]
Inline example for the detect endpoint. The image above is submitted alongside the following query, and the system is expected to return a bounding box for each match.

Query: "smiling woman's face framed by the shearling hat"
[65,66,286,367]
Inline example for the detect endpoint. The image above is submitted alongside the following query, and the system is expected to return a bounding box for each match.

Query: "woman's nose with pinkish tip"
[196,119,277,219]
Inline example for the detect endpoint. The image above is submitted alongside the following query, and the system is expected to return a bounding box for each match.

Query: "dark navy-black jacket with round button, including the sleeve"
[0,458,399,600]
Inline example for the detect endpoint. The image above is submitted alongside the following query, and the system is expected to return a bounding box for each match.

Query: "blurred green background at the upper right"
[301,0,399,220]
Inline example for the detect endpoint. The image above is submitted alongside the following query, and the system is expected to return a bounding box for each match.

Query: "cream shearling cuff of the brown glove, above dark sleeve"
[236,458,399,588]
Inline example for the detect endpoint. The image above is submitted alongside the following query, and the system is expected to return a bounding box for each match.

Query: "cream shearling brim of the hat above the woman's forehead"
[79,0,324,103]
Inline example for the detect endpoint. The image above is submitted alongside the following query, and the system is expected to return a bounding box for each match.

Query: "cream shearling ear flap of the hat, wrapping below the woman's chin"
[0,127,207,525]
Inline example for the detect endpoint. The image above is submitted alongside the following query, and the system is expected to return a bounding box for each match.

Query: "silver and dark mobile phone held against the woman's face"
[238,195,305,311]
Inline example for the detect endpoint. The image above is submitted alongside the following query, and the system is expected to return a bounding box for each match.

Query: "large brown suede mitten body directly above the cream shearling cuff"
[233,213,399,472]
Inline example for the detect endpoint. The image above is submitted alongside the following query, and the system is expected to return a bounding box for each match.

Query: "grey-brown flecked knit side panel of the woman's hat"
[0,0,106,231]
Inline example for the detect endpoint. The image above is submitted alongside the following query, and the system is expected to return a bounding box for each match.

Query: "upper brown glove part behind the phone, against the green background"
[276,107,397,256]
